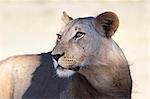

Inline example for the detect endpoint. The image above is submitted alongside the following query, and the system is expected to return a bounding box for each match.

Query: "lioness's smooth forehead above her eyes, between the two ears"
[60,17,93,39]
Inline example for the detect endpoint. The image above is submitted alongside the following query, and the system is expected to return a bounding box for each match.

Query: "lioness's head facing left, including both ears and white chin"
[52,12,119,77]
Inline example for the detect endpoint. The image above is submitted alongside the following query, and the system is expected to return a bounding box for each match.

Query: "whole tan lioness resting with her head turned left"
[0,12,132,99]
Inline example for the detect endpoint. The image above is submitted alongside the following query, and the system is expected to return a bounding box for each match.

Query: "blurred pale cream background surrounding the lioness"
[0,0,150,99]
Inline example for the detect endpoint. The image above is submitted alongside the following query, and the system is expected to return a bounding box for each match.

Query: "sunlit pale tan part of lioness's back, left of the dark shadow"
[0,55,40,99]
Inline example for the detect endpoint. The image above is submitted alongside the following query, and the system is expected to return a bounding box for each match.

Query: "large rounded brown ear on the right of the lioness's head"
[94,12,119,38]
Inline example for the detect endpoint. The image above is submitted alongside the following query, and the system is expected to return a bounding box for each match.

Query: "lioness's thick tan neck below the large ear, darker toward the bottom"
[77,40,132,99]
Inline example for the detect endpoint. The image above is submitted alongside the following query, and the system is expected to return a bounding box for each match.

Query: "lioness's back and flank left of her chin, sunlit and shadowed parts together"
[0,53,72,99]
